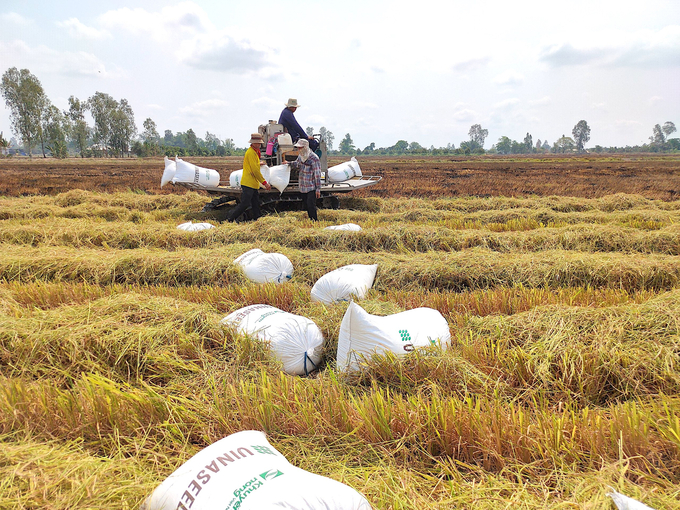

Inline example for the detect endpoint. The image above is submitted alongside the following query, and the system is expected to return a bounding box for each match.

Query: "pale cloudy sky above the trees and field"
[0,0,680,148]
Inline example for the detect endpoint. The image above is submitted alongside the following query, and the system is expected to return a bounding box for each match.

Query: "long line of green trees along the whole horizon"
[0,67,680,158]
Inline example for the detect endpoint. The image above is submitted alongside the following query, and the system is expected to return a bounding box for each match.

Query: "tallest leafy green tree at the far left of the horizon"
[0,67,48,157]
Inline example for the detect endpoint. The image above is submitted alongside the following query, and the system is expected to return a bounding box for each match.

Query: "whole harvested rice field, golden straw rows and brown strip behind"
[0,155,680,510]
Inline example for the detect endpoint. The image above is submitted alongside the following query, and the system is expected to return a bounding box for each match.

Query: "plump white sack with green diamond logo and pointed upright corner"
[337,301,451,370]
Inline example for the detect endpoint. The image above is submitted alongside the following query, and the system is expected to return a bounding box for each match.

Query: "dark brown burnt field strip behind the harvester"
[0,154,680,201]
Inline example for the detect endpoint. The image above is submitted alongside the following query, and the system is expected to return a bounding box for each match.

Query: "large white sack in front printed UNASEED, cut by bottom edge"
[141,430,371,510]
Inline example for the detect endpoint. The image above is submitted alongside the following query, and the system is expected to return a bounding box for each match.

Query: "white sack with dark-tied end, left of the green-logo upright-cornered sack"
[220,305,323,375]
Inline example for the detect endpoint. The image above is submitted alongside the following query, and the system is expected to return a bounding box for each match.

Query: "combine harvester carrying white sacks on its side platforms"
[161,120,382,221]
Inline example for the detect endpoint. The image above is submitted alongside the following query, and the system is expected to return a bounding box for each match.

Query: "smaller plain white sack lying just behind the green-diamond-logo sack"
[312,264,378,304]
